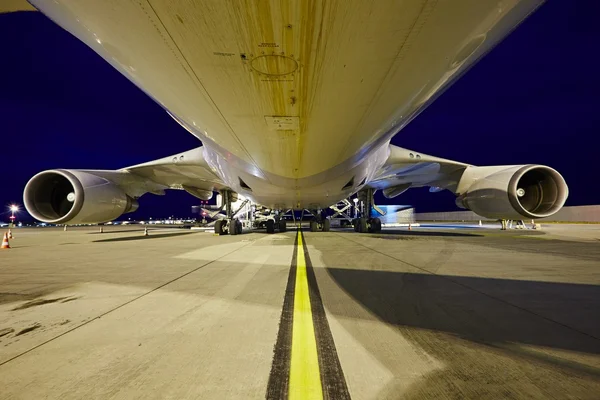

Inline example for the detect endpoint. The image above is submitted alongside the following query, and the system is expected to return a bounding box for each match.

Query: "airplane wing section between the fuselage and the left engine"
[119,147,227,198]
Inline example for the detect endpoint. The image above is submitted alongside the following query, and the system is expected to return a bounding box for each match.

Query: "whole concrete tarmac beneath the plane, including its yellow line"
[0,224,600,399]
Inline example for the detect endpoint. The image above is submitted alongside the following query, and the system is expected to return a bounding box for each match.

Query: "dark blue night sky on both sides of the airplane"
[0,0,600,220]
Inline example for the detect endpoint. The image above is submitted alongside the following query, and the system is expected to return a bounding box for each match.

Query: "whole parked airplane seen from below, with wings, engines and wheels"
[0,0,568,234]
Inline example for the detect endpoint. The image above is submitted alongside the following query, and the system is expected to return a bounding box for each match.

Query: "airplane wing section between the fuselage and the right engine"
[368,145,469,197]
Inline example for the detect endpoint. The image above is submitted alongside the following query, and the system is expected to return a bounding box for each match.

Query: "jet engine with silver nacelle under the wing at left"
[23,169,138,224]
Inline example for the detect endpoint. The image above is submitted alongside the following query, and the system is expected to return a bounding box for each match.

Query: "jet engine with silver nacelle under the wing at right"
[456,165,569,219]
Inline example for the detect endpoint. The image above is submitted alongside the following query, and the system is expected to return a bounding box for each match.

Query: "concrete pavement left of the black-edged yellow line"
[0,227,293,399]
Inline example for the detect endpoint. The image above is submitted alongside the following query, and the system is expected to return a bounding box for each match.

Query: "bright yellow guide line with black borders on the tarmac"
[266,229,350,400]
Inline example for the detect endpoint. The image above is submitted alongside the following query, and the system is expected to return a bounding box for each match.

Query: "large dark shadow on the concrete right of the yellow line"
[326,268,600,358]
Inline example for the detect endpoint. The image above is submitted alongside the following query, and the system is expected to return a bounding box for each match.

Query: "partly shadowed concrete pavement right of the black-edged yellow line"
[305,230,600,399]
